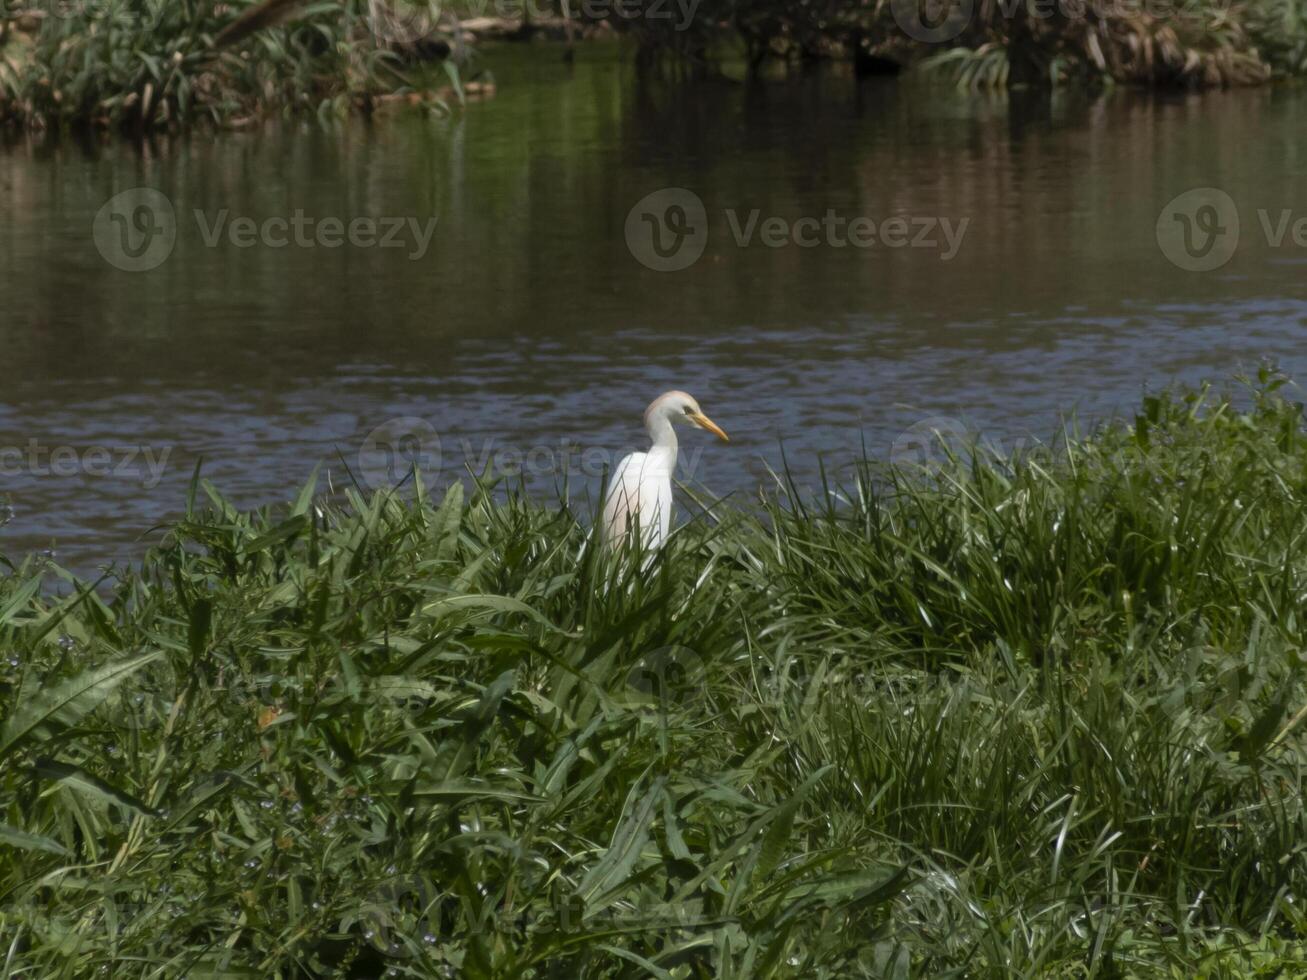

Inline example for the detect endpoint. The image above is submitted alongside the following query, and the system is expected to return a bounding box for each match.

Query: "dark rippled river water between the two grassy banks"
[0,44,1307,570]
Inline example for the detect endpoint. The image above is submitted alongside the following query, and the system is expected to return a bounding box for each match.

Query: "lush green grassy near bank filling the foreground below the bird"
[0,379,1307,977]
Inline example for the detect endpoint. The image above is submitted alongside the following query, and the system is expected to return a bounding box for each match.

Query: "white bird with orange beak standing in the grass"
[604,391,731,550]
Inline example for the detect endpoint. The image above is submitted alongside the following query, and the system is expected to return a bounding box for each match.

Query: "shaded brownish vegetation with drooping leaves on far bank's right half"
[613,0,1307,89]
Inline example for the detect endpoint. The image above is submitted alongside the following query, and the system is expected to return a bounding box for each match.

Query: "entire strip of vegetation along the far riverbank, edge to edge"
[0,0,1307,131]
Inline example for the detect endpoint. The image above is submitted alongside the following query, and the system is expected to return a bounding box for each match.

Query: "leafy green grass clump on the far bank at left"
[0,0,452,132]
